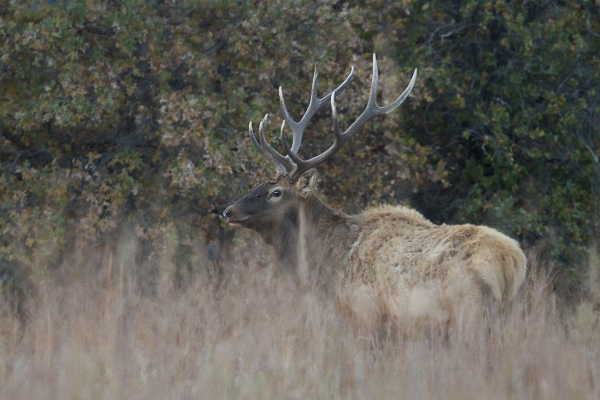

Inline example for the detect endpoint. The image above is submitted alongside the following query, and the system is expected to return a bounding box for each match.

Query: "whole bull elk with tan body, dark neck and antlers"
[223,54,526,332]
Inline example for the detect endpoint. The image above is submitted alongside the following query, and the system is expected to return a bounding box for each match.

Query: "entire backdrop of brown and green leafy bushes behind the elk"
[0,0,600,294]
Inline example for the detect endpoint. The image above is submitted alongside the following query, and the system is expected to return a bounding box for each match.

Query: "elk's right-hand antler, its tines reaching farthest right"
[282,54,417,180]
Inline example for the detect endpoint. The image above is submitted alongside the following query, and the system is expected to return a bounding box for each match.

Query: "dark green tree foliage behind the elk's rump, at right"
[386,1,600,282]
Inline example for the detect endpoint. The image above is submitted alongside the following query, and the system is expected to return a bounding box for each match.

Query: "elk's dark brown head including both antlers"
[223,54,417,244]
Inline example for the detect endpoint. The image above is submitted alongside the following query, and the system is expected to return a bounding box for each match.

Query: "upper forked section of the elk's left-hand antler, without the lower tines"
[279,63,354,154]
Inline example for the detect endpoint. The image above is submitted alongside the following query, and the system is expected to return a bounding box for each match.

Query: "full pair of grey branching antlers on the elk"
[249,54,417,182]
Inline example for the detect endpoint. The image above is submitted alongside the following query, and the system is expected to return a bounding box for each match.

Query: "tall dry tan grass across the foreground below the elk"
[0,236,600,400]
